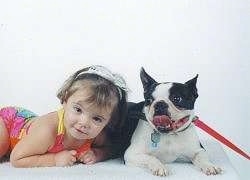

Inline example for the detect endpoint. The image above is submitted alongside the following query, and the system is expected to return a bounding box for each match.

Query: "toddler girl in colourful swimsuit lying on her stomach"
[0,66,127,167]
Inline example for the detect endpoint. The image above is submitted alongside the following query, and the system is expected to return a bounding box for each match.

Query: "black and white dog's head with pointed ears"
[140,68,198,133]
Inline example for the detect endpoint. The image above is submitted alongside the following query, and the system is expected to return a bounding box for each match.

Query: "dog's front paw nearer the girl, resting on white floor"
[148,163,171,176]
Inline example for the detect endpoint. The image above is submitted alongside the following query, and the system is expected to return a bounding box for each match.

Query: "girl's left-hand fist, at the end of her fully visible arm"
[55,150,76,166]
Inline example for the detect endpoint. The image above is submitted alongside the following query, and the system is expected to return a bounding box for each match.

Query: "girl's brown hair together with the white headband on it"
[57,66,127,129]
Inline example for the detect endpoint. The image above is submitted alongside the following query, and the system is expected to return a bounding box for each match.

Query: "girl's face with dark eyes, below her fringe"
[63,90,114,139]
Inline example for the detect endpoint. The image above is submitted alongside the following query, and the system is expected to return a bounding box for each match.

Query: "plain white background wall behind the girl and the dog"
[0,0,250,179]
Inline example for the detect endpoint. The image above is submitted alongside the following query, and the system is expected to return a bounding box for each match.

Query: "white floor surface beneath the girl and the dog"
[0,140,239,180]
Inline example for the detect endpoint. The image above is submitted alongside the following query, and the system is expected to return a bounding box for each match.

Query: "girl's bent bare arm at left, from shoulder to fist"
[10,114,76,167]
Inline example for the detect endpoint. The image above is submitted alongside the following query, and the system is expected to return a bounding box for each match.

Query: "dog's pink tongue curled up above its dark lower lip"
[153,115,173,133]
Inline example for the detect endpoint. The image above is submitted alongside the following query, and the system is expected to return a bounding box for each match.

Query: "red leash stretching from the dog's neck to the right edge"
[193,116,250,160]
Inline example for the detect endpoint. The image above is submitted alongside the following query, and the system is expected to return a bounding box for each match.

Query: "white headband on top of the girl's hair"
[76,65,130,99]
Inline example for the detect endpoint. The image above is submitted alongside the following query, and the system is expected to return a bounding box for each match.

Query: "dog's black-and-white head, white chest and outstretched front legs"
[124,68,221,176]
